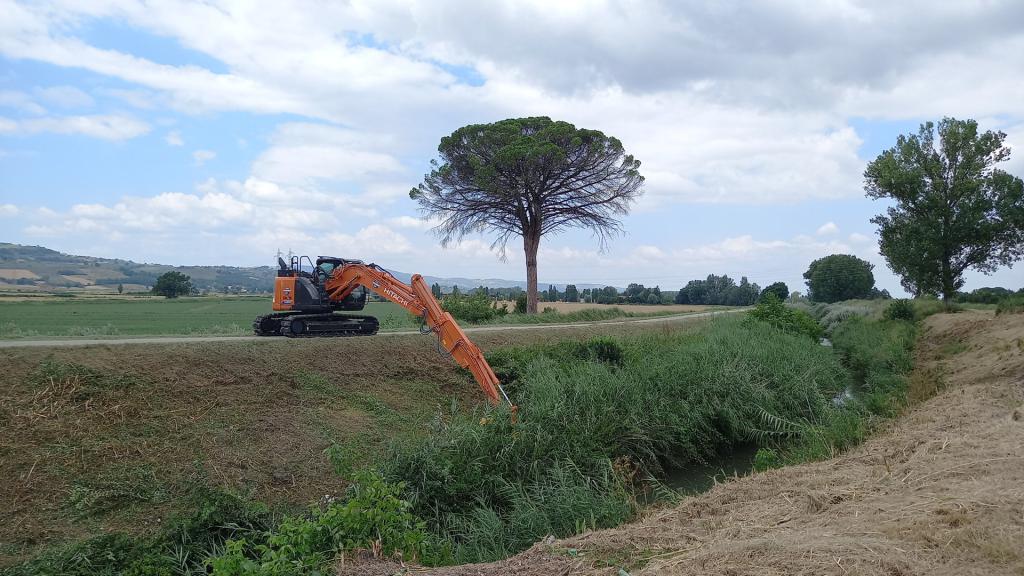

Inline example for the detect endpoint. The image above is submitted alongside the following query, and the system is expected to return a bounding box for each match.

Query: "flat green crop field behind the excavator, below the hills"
[0,296,417,338]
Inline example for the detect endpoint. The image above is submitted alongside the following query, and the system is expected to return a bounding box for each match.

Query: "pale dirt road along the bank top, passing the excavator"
[0,308,745,348]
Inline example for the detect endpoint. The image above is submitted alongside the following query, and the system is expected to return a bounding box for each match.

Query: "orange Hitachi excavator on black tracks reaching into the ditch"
[253,256,515,410]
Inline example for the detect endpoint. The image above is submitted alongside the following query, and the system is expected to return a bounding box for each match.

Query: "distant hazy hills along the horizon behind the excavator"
[0,243,600,293]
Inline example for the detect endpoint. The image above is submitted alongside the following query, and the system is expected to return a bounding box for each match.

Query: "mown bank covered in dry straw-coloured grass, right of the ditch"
[411,311,1024,576]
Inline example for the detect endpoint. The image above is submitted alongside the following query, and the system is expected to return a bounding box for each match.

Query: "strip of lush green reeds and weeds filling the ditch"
[2,297,929,574]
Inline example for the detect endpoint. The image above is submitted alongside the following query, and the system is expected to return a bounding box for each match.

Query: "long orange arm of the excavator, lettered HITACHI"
[324,262,516,412]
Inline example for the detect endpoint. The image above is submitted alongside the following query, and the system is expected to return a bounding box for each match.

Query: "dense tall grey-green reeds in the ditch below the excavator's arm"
[384,319,849,561]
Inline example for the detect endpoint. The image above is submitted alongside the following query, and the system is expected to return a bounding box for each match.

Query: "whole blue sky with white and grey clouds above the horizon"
[0,0,1024,292]
